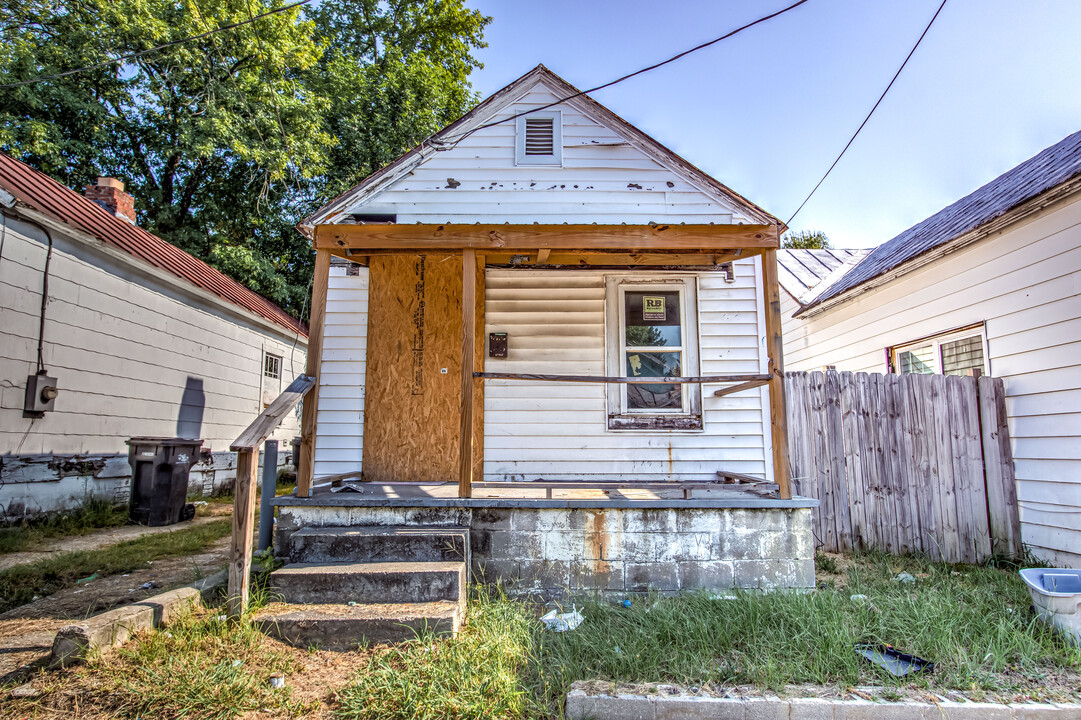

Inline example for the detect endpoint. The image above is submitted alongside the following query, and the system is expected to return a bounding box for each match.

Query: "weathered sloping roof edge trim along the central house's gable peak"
[297,65,784,231]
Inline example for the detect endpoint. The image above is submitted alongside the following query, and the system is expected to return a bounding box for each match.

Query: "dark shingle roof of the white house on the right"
[804,132,1081,309]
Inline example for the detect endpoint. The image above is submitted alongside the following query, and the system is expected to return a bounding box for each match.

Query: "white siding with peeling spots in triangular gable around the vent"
[348,81,751,225]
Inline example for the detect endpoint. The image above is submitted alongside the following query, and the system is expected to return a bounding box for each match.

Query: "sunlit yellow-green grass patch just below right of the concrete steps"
[338,589,543,720]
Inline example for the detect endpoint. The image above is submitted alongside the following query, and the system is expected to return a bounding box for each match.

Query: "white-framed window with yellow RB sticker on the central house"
[608,278,702,430]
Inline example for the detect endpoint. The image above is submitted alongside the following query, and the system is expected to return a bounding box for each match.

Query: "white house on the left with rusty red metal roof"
[0,154,307,519]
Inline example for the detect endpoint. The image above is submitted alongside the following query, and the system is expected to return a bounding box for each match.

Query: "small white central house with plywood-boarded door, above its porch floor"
[303,66,779,488]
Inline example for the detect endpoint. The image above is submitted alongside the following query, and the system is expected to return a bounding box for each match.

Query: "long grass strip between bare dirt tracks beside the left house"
[0,518,232,612]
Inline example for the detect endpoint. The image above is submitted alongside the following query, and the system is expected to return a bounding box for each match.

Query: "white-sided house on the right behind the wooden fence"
[782,132,1081,566]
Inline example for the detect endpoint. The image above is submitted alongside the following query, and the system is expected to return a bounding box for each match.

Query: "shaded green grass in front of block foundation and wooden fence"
[541,555,1081,692]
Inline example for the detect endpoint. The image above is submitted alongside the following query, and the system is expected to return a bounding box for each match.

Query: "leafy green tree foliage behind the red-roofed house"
[0,0,491,314]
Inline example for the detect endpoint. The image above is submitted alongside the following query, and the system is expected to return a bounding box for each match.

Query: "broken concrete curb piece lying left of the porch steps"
[50,570,229,666]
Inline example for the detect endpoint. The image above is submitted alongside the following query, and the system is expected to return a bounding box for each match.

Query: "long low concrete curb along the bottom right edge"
[564,685,1081,720]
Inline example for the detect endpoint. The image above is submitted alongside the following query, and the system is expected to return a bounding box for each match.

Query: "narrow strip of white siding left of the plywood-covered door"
[315,265,368,480]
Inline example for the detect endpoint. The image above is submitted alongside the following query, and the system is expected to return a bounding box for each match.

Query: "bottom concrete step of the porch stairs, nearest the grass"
[254,601,464,651]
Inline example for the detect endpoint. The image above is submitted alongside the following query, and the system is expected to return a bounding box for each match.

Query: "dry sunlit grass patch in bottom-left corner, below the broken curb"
[12,610,309,720]
